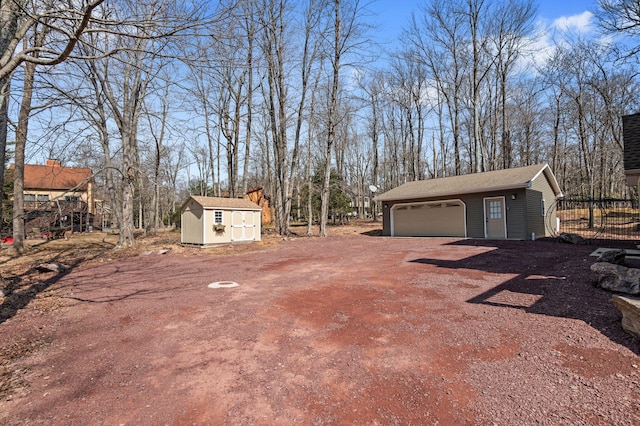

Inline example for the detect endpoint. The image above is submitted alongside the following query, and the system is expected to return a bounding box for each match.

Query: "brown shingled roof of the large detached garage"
[375,164,562,201]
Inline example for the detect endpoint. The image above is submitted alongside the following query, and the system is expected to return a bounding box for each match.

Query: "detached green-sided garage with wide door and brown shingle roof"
[376,164,562,240]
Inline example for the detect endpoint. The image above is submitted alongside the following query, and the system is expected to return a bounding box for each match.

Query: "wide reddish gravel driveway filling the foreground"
[0,235,640,425]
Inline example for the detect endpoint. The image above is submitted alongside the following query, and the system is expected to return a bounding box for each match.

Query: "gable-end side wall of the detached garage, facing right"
[527,174,556,238]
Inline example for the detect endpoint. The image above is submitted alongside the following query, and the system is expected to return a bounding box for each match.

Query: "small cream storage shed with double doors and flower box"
[180,196,262,246]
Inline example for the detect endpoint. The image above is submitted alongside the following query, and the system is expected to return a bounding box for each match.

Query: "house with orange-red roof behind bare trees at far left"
[10,160,96,233]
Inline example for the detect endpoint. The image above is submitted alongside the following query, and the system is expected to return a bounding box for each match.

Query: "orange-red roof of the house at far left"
[11,163,92,190]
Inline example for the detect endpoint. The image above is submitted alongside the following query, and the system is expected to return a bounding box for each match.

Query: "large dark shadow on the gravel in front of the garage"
[411,240,640,355]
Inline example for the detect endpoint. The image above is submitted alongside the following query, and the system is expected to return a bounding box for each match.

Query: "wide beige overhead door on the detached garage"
[391,200,467,237]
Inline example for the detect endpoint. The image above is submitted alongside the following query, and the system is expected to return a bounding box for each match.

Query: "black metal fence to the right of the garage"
[556,197,640,244]
